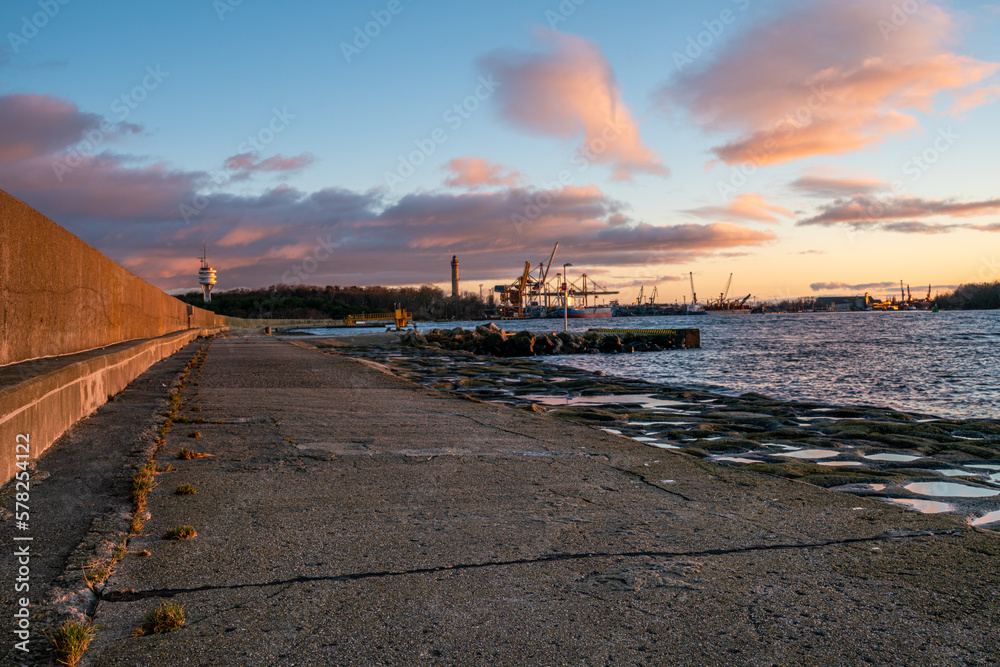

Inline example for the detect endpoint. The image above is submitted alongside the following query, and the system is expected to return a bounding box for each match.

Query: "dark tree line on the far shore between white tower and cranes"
[177,284,492,320]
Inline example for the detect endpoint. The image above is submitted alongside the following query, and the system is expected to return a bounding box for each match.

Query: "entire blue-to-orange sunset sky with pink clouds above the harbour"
[0,0,1000,302]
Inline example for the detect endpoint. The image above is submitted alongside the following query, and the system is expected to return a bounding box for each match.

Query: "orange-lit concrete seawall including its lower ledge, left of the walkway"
[0,191,226,483]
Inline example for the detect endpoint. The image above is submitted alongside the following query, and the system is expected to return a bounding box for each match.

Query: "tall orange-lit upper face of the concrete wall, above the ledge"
[0,190,224,366]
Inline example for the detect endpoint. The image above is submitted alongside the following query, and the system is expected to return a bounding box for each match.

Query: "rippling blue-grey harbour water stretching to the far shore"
[304,311,1000,419]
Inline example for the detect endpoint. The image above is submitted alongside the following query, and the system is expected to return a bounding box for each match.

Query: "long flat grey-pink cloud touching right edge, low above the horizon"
[795,195,1000,231]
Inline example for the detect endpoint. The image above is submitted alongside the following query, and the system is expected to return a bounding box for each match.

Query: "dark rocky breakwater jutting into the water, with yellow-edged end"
[400,322,700,357]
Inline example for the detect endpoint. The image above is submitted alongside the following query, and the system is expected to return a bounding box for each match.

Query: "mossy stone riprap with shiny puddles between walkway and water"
[332,340,1000,527]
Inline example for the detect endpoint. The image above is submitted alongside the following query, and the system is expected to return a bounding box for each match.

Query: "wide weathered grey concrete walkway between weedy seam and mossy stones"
[84,337,1000,665]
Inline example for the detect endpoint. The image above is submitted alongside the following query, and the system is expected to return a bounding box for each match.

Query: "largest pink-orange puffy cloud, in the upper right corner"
[658,0,1000,164]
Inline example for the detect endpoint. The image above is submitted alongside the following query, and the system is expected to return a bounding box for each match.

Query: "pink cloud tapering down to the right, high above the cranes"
[480,31,669,180]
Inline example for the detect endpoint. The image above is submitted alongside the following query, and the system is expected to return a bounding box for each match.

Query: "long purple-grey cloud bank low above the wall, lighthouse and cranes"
[0,96,775,288]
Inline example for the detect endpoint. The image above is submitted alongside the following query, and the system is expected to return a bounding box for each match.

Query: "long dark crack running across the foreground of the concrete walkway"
[101,530,965,602]
